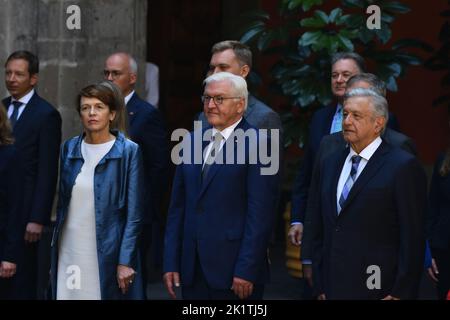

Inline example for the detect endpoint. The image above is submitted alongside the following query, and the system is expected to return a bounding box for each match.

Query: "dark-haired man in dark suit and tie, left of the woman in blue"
[3,51,61,299]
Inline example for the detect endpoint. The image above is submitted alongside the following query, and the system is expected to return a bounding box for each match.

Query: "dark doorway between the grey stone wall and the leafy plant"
[147,0,222,133]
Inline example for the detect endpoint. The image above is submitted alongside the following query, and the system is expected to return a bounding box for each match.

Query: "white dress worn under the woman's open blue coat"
[56,140,115,300]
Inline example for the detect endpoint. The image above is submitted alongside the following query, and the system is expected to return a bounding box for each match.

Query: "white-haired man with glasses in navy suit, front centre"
[163,72,279,300]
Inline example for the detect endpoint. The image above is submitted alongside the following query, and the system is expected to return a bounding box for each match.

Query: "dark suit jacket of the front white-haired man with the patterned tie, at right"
[311,142,426,299]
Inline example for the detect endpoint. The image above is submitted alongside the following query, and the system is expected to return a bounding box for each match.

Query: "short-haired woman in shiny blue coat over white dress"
[51,82,144,300]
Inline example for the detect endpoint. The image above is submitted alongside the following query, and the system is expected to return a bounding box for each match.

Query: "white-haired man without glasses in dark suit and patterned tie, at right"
[311,88,426,299]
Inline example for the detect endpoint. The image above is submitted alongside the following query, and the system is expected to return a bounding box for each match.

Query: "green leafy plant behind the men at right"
[241,0,432,147]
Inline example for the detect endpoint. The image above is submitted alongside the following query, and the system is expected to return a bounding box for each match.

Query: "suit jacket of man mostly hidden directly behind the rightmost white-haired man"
[301,128,417,260]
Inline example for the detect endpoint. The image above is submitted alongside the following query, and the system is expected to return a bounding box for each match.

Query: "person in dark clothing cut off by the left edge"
[0,106,25,300]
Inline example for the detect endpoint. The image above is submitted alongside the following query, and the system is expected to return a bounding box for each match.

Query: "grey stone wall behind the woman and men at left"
[0,0,147,139]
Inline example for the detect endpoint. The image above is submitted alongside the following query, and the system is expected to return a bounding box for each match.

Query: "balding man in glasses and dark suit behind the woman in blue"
[103,52,169,298]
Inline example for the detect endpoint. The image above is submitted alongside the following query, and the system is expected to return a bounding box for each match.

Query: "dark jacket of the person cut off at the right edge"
[427,154,450,250]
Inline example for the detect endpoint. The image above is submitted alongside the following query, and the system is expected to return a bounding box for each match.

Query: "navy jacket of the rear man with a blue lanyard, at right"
[291,105,398,222]
